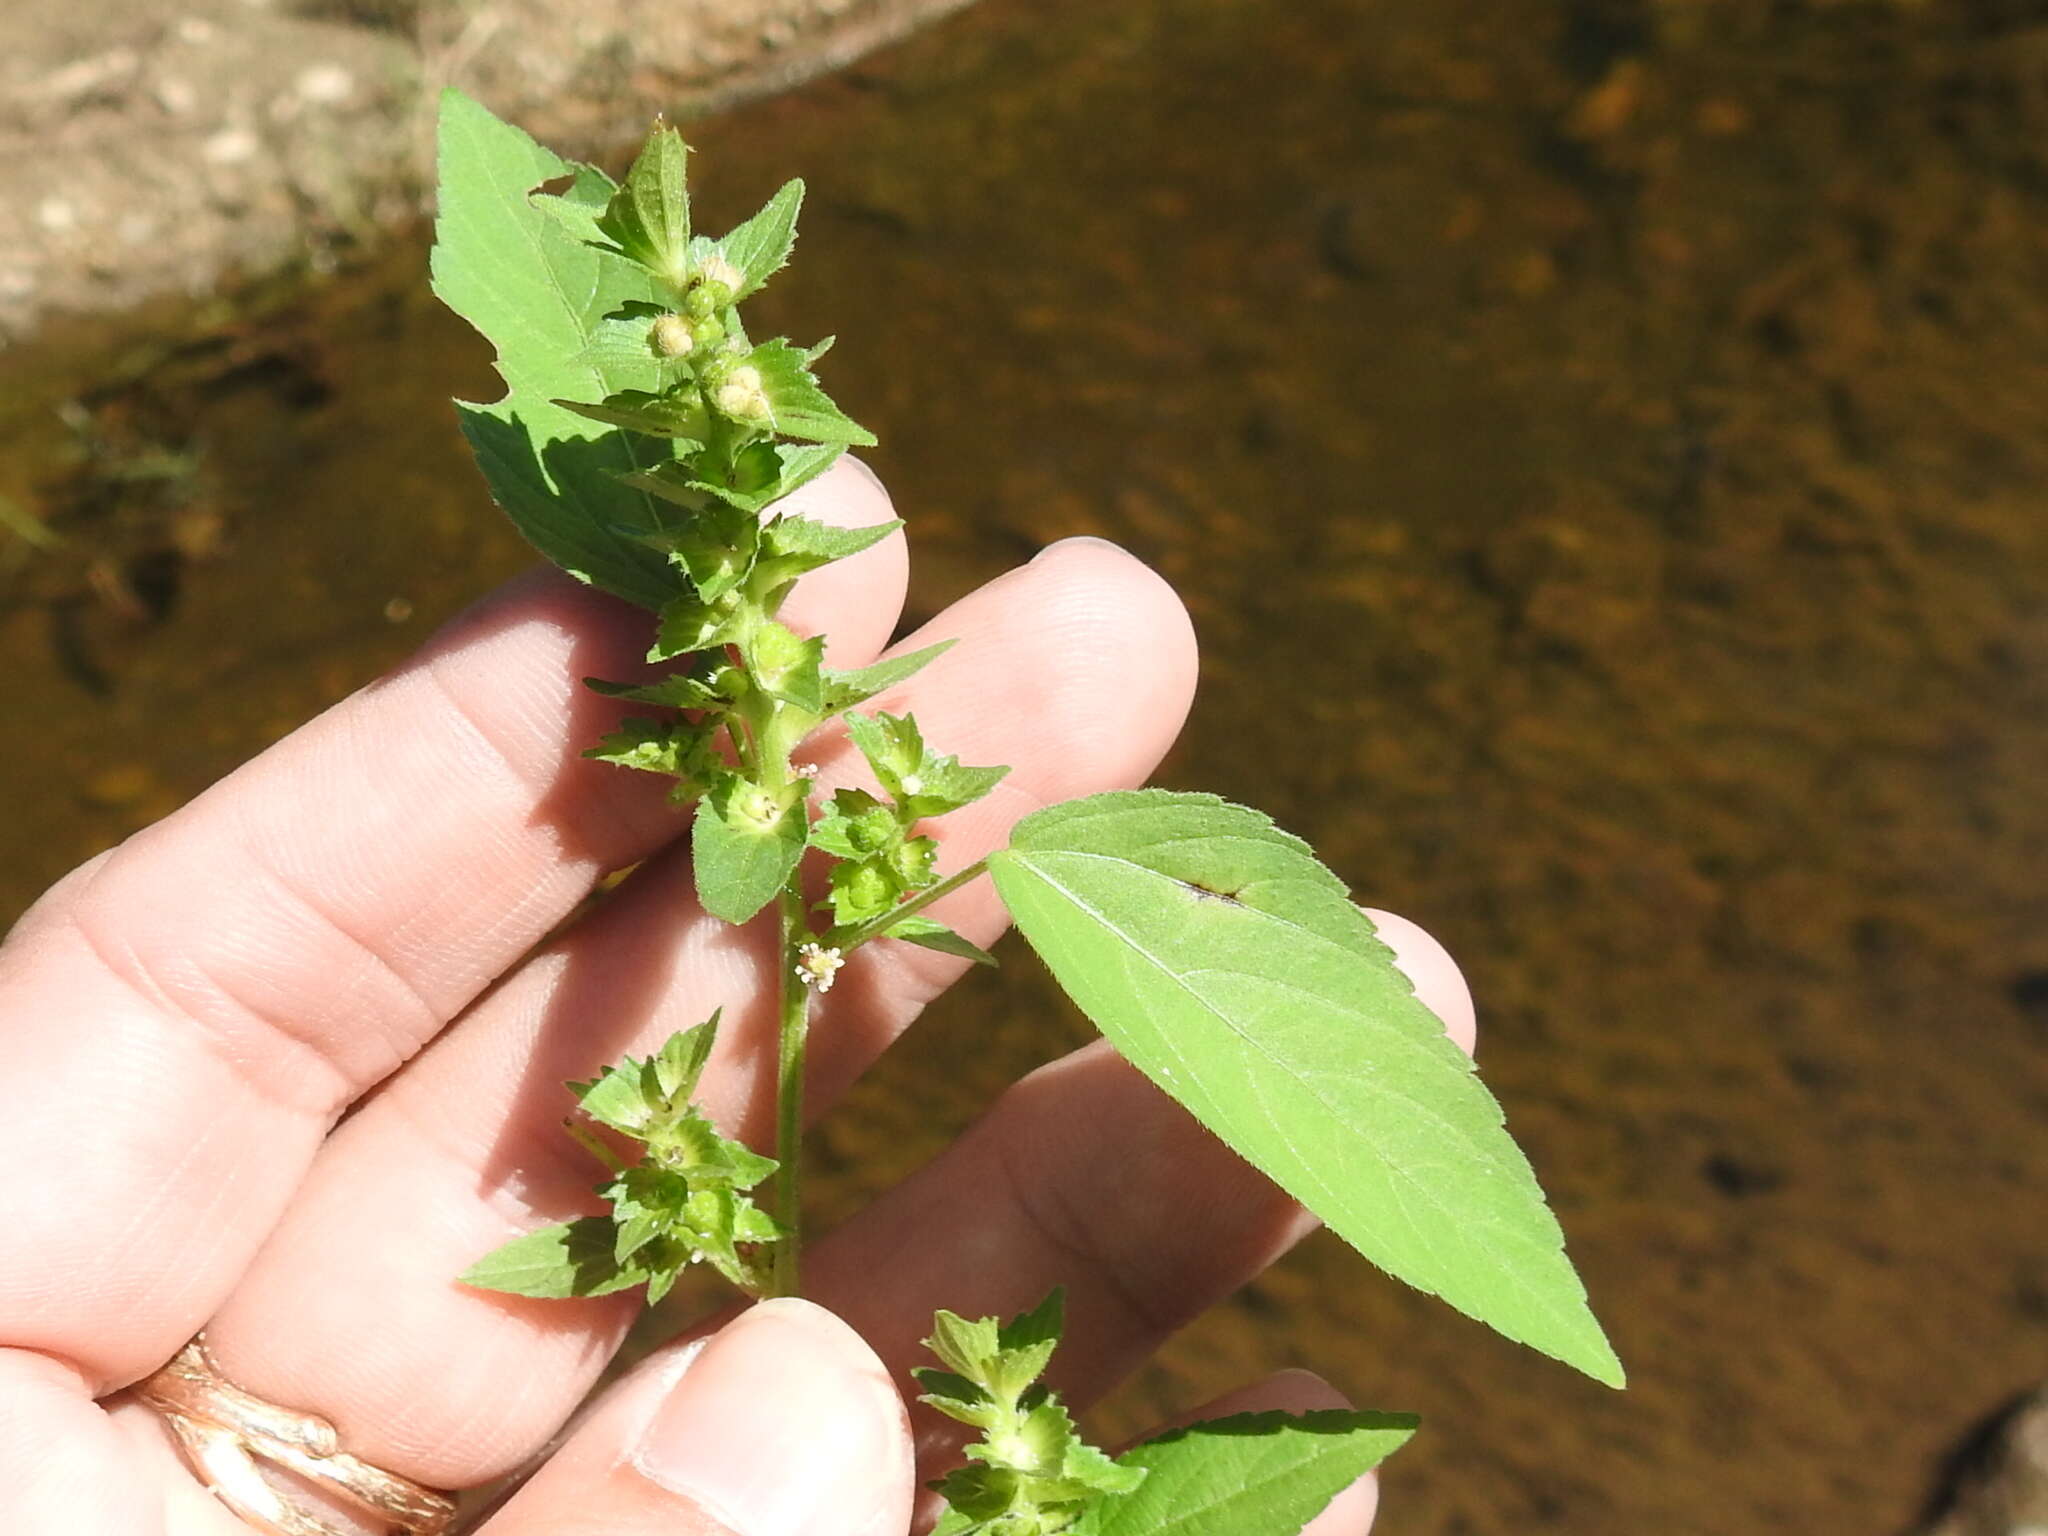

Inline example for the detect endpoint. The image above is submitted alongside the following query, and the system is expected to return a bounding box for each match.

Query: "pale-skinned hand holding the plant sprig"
[0,463,1473,1536]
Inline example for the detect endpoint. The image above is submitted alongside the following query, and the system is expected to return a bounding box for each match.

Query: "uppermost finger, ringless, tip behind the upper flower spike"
[0,469,903,1391]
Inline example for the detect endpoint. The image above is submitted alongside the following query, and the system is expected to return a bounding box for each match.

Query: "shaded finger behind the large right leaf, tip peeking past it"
[809,913,1470,1458]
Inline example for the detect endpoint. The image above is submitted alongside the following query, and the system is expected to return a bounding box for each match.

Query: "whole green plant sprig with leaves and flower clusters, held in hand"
[434,92,1622,1536]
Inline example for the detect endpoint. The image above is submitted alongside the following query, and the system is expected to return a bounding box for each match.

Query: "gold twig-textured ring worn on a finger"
[135,1333,455,1536]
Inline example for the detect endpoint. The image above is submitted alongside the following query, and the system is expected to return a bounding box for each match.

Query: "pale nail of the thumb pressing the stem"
[633,1300,909,1536]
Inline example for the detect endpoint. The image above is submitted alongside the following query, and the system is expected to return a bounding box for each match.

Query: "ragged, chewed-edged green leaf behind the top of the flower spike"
[432,90,678,608]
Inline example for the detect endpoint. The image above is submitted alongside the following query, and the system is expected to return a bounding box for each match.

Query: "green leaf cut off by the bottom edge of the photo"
[1079,1409,1415,1536]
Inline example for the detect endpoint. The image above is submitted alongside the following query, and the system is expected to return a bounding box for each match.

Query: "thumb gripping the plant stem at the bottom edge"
[481,1300,915,1536]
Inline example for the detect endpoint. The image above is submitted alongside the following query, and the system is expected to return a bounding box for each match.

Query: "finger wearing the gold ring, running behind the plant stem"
[192,545,1194,1487]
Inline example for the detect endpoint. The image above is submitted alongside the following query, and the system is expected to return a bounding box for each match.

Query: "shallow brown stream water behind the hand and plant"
[0,0,2048,1536]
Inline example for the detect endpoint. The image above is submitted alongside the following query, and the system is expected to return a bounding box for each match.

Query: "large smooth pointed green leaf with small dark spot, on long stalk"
[989,791,1622,1386]
